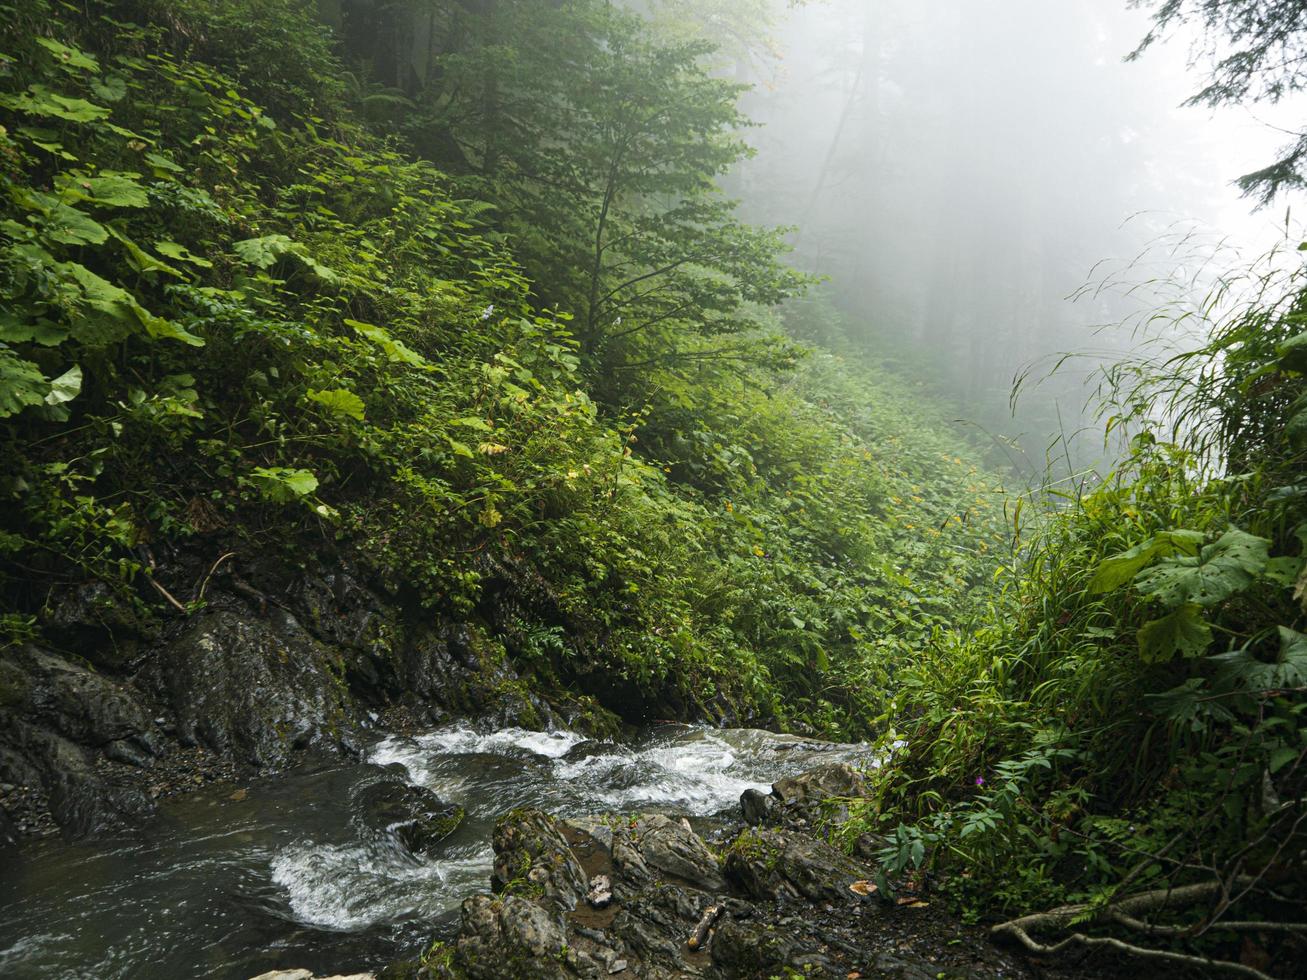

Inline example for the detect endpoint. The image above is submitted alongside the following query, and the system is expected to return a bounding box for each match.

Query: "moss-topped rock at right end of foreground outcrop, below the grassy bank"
[725,830,864,902]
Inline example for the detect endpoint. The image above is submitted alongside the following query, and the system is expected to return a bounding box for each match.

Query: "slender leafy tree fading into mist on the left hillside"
[346,0,804,401]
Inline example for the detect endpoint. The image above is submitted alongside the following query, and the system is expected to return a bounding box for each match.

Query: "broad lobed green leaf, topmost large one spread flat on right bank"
[1134,528,1270,609]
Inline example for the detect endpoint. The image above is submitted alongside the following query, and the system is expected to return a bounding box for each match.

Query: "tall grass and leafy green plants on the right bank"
[847,244,1307,955]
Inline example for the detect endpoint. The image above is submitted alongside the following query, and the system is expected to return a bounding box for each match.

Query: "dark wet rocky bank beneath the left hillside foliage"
[0,555,640,845]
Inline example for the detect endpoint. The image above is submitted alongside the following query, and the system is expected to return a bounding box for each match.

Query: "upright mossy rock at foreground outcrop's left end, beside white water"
[491,810,588,912]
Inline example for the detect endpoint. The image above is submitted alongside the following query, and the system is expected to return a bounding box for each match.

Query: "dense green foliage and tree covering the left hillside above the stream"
[0,0,1002,733]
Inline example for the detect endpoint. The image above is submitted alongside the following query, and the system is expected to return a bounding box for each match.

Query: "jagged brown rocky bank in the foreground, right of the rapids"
[247,764,1134,980]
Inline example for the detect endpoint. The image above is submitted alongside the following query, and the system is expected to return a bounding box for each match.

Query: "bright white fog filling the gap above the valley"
[725,0,1293,473]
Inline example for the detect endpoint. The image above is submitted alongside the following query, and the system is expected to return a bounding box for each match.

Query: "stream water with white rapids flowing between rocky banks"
[0,725,873,980]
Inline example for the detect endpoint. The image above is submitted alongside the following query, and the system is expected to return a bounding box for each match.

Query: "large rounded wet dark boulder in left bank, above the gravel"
[156,608,353,768]
